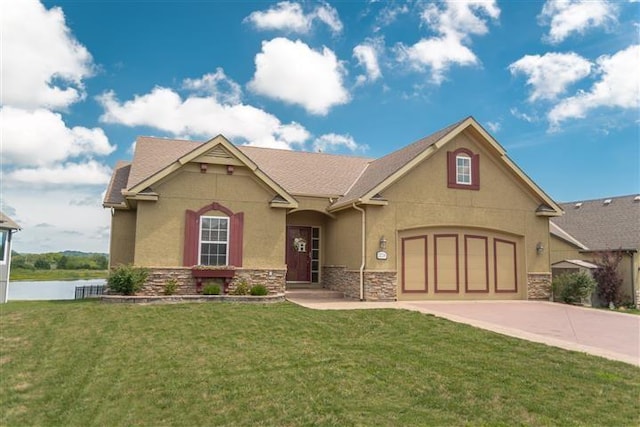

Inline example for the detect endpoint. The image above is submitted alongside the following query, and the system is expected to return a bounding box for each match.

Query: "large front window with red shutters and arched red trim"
[183,202,244,267]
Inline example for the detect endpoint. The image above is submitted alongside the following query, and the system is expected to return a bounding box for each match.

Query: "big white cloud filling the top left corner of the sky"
[0,0,93,109]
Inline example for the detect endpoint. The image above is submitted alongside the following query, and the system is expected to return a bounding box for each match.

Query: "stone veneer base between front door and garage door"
[322,266,397,301]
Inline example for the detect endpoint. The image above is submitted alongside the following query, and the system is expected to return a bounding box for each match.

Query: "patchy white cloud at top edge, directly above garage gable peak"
[396,0,500,84]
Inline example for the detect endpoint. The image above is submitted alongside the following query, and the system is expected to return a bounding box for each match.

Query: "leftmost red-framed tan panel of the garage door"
[402,236,428,293]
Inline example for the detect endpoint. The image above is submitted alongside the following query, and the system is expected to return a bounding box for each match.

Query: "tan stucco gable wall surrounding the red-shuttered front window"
[135,165,286,268]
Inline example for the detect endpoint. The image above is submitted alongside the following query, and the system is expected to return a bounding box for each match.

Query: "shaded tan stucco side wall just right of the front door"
[323,209,362,270]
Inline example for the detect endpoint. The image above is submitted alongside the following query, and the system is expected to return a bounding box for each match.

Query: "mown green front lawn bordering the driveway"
[0,301,640,426]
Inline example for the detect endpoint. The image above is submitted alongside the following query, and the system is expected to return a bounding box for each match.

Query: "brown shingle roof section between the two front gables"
[238,146,372,197]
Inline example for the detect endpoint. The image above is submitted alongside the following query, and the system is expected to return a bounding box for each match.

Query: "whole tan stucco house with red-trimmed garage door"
[104,117,562,300]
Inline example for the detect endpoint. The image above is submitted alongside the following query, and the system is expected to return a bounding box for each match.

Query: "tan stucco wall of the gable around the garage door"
[367,134,550,272]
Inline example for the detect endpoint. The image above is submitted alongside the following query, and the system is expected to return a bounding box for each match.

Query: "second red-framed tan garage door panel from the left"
[433,234,459,292]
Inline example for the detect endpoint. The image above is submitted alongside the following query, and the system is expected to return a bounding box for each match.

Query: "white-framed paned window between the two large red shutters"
[198,216,229,265]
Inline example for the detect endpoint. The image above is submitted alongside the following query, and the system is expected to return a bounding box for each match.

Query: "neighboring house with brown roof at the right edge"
[550,195,640,305]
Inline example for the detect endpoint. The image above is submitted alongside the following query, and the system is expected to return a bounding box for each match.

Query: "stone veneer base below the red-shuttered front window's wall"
[119,267,286,296]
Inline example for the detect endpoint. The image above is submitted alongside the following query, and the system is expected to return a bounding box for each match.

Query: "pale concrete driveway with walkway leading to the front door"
[286,290,640,367]
